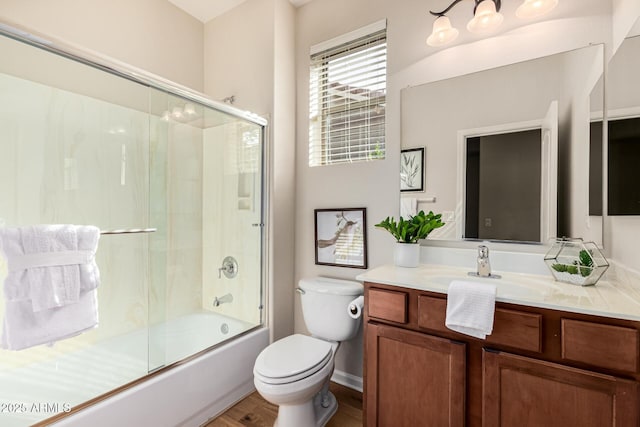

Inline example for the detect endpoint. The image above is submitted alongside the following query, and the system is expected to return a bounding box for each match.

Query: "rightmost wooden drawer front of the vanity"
[562,319,638,373]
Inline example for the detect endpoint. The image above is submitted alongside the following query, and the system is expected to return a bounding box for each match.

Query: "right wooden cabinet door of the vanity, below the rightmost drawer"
[482,350,639,427]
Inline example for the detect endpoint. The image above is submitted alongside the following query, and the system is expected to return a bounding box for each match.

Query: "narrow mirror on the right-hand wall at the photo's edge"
[590,19,640,270]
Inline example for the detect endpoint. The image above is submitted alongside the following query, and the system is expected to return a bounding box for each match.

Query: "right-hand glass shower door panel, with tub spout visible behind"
[149,89,263,370]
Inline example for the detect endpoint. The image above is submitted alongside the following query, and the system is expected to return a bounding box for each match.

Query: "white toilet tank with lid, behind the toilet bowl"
[298,277,364,341]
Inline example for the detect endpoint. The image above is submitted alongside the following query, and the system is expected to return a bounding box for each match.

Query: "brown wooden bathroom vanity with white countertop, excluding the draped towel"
[358,265,640,427]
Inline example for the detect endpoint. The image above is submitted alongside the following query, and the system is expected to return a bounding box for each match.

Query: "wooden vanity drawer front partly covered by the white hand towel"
[418,295,542,353]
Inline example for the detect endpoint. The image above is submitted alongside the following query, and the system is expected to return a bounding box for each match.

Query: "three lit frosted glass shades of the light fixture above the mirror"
[427,0,558,47]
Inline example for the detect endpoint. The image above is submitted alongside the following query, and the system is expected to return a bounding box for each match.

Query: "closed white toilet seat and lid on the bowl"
[254,334,333,384]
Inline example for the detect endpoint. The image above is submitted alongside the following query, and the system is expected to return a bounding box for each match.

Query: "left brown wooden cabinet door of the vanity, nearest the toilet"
[365,324,465,427]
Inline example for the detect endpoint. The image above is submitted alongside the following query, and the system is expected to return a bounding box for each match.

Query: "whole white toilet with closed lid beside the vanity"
[253,277,364,427]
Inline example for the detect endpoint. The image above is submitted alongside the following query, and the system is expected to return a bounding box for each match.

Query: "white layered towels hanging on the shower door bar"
[0,225,100,350]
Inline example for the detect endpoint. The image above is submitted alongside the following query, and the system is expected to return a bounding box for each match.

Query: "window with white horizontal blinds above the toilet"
[309,23,387,166]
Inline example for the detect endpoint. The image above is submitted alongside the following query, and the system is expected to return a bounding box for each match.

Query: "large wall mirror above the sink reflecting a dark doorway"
[401,45,604,243]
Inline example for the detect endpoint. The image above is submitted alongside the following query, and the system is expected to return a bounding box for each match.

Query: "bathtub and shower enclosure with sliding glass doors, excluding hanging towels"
[0,25,268,427]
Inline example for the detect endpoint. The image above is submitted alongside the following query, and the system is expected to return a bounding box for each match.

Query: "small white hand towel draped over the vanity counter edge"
[445,280,496,339]
